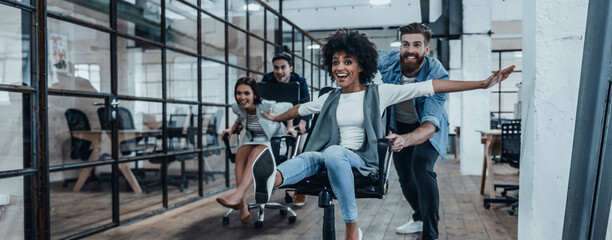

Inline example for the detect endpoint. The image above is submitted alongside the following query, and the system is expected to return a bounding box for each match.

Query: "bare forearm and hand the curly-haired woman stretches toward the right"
[432,65,514,93]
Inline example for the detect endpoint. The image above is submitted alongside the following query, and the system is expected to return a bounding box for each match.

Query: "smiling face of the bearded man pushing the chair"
[400,33,430,77]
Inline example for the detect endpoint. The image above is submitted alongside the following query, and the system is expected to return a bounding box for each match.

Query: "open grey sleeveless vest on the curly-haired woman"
[304,84,385,176]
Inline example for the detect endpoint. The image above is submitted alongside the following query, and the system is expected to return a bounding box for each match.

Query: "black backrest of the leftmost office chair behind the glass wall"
[64,108,93,161]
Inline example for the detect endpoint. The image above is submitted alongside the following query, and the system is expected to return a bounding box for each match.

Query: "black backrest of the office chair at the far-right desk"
[500,120,521,168]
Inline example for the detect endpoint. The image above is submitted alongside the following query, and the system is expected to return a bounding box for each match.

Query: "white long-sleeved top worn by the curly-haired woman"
[298,80,435,149]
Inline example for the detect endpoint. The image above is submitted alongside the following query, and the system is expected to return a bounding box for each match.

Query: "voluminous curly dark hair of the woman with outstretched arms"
[321,29,378,85]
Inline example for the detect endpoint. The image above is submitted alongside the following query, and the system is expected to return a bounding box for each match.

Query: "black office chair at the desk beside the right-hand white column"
[483,120,521,215]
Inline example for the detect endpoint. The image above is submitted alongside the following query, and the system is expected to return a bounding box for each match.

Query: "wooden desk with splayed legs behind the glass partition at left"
[71,130,161,194]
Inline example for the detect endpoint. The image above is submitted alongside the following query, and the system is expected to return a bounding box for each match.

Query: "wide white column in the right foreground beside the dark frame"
[518,0,588,239]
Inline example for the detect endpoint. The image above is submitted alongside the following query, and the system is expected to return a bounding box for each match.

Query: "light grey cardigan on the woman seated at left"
[232,100,293,152]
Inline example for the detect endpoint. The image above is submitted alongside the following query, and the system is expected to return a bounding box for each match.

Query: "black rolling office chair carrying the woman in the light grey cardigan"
[223,127,297,228]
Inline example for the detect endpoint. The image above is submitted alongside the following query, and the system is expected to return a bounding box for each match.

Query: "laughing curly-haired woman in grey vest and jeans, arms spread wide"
[246,29,513,239]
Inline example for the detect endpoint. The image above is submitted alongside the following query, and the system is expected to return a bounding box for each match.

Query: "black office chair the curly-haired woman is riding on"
[282,87,391,240]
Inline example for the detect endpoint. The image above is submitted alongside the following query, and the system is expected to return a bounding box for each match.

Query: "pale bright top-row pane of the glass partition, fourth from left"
[166,0,198,53]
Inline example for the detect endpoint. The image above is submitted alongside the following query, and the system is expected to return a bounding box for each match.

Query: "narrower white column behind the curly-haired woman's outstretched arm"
[459,0,491,175]
